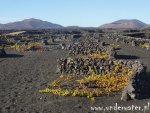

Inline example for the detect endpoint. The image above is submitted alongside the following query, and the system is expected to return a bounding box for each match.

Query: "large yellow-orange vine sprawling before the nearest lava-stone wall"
[40,62,132,100]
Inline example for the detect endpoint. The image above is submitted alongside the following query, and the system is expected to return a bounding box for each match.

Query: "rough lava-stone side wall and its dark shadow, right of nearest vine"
[121,61,150,101]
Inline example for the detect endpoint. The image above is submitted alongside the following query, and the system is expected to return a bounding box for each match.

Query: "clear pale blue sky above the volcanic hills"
[0,0,150,27]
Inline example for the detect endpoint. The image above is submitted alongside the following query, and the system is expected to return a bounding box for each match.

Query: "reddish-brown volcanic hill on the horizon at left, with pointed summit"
[0,18,63,29]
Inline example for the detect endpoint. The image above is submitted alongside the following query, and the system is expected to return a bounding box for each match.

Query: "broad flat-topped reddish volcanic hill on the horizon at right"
[100,19,147,29]
